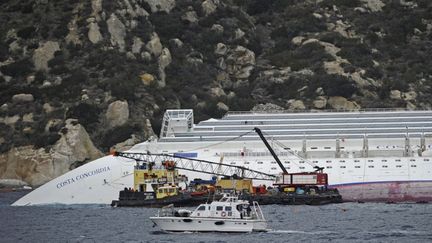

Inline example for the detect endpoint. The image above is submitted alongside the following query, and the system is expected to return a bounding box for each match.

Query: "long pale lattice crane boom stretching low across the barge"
[112,152,276,181]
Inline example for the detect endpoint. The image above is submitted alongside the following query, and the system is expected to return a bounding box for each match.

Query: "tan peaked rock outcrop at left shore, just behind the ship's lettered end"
[0,119,103,186]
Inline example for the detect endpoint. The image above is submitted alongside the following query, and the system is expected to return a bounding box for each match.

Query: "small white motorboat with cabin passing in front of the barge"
[150,195,267,232]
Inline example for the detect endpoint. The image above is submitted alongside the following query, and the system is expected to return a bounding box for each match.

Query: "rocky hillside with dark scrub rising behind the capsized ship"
[0,0,432,185]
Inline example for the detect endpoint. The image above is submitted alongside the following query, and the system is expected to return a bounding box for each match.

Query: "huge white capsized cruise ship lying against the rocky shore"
[13,109,432,205]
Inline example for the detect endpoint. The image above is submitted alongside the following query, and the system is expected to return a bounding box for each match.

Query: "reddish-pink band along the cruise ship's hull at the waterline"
[331,181,432,202]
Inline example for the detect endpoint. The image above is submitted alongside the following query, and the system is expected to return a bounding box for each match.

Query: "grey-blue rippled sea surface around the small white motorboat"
[0,192,432,243]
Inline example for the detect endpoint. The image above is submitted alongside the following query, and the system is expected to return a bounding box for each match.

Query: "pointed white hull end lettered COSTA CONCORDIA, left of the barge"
[12,156,135,206]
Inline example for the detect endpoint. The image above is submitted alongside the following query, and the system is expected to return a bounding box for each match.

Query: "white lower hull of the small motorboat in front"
[150,217,267,233]
